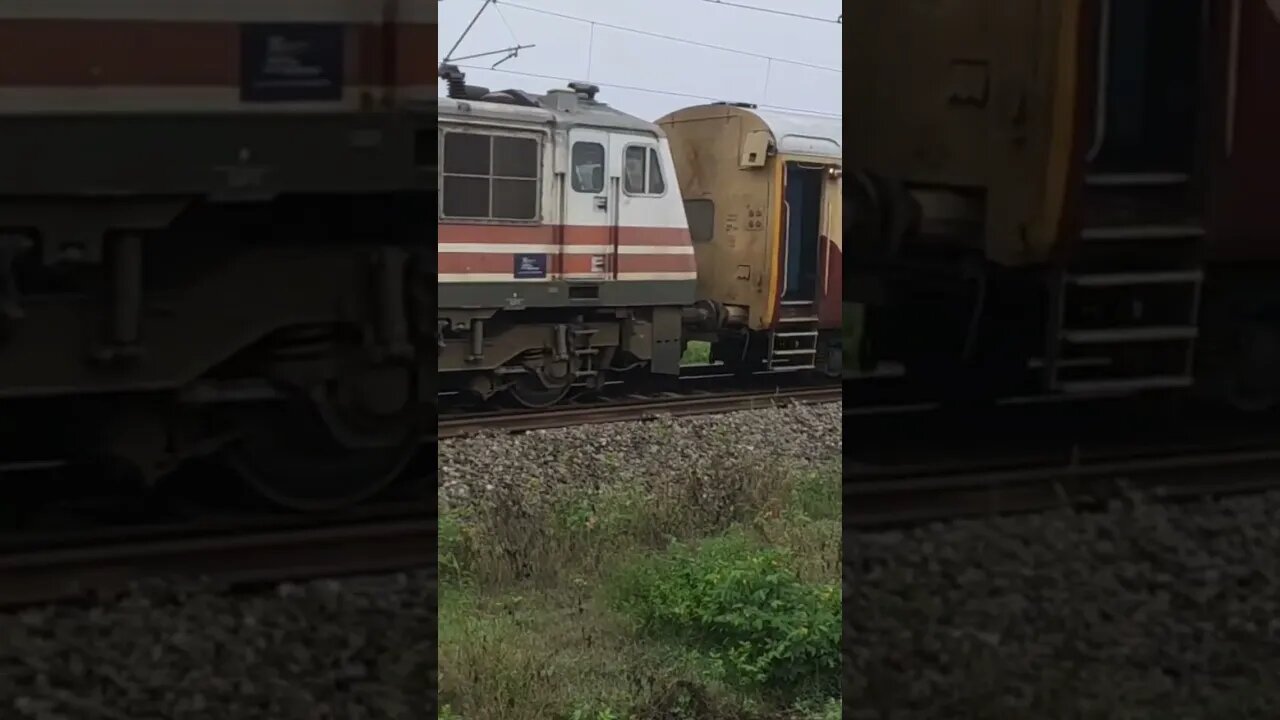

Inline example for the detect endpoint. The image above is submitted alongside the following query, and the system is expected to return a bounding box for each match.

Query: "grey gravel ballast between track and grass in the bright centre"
[439,402,841,503]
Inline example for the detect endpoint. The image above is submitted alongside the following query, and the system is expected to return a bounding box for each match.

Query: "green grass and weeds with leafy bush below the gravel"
[439,459,840,720]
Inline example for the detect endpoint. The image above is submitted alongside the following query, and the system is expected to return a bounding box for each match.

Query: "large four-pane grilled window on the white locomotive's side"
[440,132,540,220]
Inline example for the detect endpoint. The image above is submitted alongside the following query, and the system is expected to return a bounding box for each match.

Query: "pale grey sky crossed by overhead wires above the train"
[439,0,842,120]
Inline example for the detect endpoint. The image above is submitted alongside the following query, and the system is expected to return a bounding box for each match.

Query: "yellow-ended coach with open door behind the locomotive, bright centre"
[658,102,844,375]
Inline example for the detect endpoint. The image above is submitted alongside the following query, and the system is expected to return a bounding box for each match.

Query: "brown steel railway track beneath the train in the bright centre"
[436,386,842,439]
